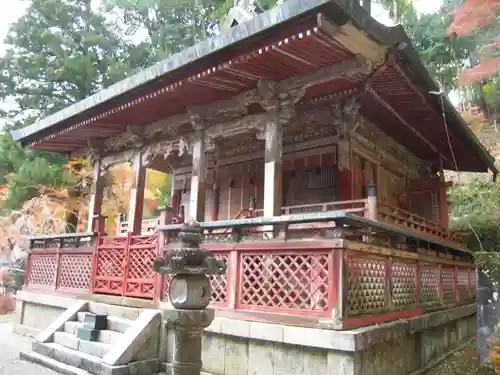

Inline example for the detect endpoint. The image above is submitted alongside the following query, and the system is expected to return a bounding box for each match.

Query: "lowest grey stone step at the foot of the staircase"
[33,342,160,375]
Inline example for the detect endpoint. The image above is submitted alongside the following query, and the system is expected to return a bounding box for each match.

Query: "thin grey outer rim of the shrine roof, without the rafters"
[12,0,496,170]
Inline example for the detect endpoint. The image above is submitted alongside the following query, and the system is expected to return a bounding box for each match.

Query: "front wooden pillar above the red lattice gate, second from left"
[127,152,146,234]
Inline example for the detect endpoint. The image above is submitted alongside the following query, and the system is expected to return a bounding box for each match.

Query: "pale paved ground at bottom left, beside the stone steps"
[0,316,57,375]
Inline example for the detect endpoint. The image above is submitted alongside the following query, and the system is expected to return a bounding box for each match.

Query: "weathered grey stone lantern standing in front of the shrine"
[153,223,226,375]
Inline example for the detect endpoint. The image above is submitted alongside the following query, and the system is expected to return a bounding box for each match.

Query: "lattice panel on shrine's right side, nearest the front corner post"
[345,256,386,316]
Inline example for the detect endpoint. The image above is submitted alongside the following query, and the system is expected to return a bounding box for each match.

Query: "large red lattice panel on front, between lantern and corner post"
[239,253,328,313]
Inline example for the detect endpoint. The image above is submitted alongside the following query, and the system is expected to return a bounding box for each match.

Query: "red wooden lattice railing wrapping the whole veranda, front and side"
[26,211,476,328]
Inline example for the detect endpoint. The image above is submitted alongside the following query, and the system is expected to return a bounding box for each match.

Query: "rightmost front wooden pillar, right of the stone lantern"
[264,116,283,217]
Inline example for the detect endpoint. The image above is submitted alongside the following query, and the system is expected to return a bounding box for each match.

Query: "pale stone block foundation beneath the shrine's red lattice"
[14,292,476,375]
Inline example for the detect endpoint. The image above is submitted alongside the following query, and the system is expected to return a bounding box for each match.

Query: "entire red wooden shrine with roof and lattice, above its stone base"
[13,0,497,329]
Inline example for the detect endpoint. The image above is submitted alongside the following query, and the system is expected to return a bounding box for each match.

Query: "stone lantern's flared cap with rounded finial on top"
[153,222,226,275]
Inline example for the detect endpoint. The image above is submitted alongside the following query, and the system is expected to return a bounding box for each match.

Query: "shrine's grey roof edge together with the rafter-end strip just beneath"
[12,0,496,175]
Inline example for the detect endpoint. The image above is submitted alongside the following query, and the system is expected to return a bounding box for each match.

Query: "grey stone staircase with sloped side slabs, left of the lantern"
[20,301,161,375]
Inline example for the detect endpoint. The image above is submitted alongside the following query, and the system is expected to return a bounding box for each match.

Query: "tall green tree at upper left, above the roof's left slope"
[0,0,139,120]
